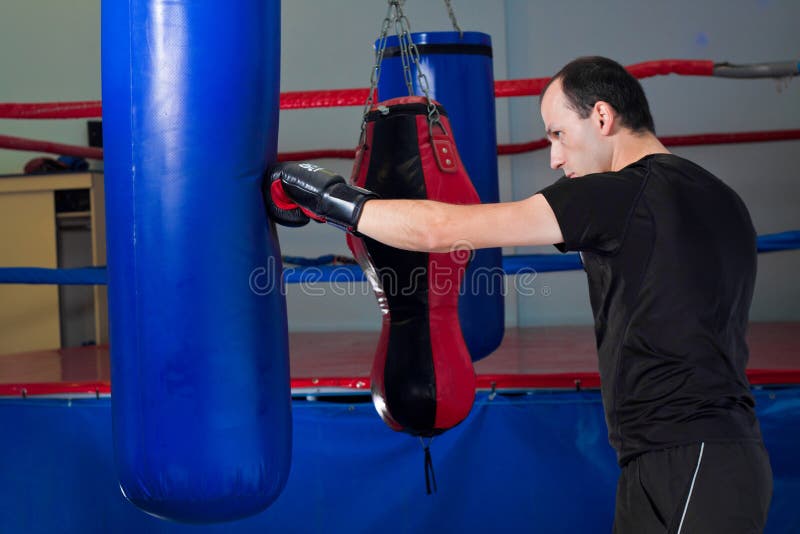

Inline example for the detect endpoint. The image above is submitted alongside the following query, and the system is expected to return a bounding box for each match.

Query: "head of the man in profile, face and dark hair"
[540,56,655,178]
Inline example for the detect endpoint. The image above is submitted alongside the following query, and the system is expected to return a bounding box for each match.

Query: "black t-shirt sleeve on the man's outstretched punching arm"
[540,173,642,254]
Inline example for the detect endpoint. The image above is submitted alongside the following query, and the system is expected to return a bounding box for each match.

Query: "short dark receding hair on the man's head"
[542,56,656,133]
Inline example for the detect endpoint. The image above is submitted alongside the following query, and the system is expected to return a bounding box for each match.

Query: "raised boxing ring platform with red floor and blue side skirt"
[0,323,800,533]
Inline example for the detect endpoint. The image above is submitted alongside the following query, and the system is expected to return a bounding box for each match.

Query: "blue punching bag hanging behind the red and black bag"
[376,32,505,361]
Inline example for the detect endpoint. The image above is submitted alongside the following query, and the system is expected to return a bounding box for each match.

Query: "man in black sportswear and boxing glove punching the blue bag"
[271,57,772,533]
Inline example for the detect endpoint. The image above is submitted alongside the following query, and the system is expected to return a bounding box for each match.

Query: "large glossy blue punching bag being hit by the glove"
[102,0,291,523]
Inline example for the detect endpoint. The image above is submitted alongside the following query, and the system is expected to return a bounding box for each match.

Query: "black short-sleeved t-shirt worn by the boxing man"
[541,154,761,465]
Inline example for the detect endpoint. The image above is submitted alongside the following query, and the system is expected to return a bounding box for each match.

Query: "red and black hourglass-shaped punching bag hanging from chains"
[347,96,480,437]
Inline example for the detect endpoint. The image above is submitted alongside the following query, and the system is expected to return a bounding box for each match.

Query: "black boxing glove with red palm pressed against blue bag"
[269,163,379,234]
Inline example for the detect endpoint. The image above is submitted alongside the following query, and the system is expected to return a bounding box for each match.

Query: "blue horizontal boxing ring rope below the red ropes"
[0,230,800,285]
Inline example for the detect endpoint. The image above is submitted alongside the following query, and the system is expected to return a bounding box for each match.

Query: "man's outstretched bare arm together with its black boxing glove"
[269,164,563,252]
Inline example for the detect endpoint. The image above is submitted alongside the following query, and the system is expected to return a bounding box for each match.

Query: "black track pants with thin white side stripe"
[614,441,772,534]
